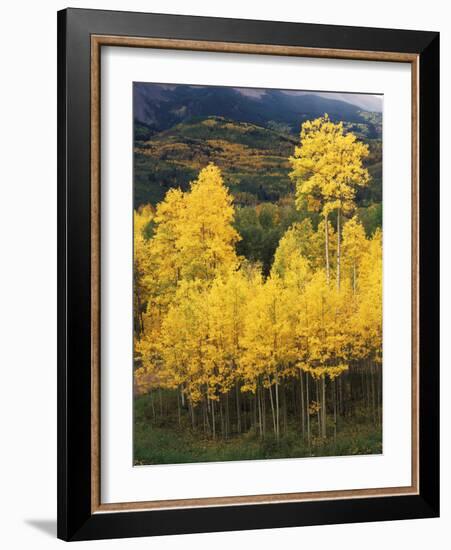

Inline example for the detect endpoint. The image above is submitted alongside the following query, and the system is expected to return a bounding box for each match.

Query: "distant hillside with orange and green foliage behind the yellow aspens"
[134,116,382,207]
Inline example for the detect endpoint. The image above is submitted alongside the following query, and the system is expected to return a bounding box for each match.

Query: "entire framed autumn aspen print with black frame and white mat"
[58,9,439,540]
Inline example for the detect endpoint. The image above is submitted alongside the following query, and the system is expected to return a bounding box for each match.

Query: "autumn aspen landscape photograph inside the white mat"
[132,82,384,466]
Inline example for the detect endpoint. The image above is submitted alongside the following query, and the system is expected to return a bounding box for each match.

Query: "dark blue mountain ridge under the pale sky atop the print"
[133,82,382,139]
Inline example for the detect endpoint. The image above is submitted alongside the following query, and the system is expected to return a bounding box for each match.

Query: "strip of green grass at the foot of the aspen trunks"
[134,396,382,465]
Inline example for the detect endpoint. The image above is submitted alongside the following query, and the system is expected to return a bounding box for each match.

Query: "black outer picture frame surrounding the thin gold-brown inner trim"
[58,9,440,540]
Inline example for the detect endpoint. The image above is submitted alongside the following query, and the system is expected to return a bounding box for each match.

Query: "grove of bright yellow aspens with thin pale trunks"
[134,115,382,455]
